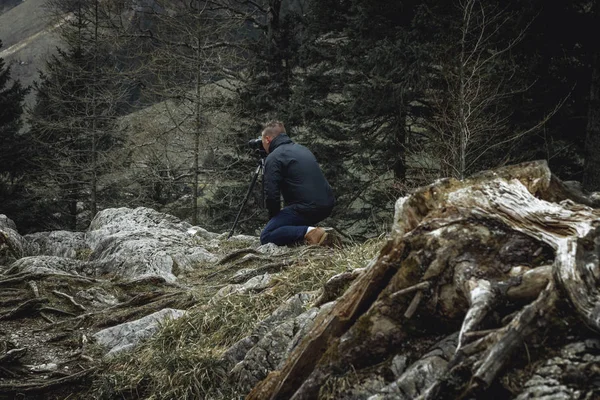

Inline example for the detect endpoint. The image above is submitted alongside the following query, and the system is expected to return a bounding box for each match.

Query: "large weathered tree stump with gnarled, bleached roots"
[247,162,600,400]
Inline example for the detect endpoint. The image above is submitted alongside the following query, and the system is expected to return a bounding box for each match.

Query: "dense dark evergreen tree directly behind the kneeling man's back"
[291,0,430,238]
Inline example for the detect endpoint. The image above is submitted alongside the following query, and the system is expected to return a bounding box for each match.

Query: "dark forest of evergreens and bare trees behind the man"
[0,0,600,240]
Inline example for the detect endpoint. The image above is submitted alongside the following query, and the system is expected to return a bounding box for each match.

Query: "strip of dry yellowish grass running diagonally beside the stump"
[92,240,383,399]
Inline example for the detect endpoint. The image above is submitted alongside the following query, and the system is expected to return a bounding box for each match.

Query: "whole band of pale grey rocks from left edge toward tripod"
[0,207,220,282]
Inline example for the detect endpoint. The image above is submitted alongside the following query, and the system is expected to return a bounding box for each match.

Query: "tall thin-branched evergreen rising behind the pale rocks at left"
[32,0,127,229]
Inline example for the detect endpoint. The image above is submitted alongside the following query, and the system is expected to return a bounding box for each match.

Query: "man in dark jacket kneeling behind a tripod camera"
[260,121,337,246]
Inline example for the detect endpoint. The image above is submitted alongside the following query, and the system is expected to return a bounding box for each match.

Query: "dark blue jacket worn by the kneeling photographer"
[264,133,335,218]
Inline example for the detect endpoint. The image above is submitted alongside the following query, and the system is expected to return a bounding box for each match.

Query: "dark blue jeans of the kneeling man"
[260,207,331,246]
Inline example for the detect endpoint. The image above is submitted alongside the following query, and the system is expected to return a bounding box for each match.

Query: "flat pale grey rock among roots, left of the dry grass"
[93,308,187,357]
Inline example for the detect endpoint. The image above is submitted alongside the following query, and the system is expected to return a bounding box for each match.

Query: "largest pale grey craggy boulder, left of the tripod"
[86,207,217,282]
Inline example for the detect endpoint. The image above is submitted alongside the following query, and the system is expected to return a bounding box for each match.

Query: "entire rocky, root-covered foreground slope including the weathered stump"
[0,162,600,400]
